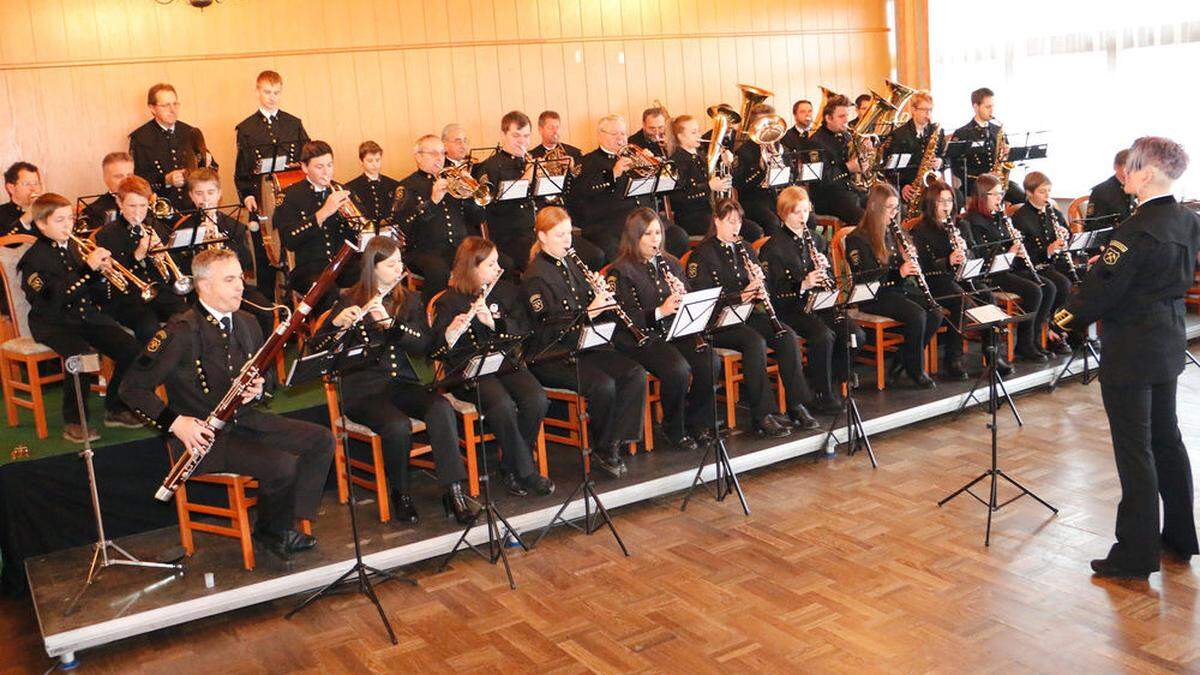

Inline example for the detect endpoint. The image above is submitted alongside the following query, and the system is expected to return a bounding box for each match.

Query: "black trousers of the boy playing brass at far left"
[29,316,138,424]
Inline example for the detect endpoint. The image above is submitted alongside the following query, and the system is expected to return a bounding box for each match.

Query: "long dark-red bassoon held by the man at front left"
[155,241,356,502]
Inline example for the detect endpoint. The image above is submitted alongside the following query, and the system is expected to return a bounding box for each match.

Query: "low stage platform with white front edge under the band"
[26,324,1200,662]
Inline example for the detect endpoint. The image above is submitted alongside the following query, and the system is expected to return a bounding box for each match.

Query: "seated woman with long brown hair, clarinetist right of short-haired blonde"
[845,183,942,389]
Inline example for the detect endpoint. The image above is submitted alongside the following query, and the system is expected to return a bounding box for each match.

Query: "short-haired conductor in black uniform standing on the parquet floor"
[1055,137,1200,579]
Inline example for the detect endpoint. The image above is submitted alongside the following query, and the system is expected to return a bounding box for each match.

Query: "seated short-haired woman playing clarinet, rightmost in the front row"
[1013,171,1079,354]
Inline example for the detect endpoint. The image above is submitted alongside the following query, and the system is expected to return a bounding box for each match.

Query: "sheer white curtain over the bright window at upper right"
[929,0,1200,198]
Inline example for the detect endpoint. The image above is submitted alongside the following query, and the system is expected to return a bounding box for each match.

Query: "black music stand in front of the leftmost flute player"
[283,330,419,645]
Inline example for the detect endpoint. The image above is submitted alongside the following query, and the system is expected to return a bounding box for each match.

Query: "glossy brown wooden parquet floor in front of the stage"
[0,369,1200,674]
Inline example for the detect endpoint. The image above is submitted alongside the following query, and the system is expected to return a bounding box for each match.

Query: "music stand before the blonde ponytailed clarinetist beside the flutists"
[530,307,629,557]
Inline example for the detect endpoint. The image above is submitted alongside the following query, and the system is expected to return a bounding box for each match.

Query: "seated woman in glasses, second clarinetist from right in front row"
[960,173,1055,363]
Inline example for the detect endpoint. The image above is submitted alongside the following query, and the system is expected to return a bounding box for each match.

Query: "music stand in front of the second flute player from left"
[431,338,529,590]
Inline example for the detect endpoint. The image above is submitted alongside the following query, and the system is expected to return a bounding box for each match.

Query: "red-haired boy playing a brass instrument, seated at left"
[95,175,187,345]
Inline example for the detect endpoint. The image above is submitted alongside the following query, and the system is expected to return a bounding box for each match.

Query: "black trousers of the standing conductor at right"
[1100,377,1200,571]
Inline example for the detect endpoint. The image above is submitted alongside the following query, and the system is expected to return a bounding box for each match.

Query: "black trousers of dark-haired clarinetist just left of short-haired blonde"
[714,312,812,422]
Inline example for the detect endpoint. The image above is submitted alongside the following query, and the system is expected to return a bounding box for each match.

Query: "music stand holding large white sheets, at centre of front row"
[681,286,755,515]
